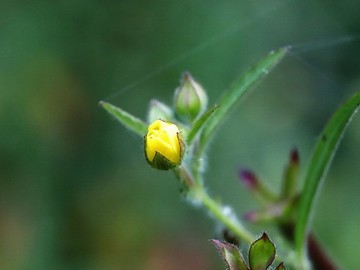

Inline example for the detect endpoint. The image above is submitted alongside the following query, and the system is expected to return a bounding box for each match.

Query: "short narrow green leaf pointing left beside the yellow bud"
[100,101,147,136]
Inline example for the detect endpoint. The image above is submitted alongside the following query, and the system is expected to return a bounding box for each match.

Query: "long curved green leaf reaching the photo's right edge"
[295,93,360,258]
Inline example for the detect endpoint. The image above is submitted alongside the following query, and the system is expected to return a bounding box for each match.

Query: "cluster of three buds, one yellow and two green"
[144,72,208,170]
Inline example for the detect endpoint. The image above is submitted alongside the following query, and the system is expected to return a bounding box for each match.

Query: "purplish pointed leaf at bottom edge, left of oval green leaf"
[211,239,249,270]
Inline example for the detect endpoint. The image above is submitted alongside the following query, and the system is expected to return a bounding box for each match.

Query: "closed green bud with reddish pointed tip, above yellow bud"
[174,72,208,121]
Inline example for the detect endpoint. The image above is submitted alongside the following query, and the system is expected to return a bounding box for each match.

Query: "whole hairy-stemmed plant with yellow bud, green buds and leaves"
[100,48,360,270]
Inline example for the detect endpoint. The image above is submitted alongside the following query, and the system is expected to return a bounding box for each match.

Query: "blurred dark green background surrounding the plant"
[0,0,360,270]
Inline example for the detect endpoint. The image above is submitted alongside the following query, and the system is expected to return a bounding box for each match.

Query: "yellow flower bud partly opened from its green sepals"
[144,120,184,170]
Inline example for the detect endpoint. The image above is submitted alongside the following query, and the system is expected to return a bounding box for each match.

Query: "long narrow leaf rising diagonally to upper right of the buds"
[200,47,288,151]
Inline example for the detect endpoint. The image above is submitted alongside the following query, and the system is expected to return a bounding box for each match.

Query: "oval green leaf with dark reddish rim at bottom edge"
[249,233,276,270]
